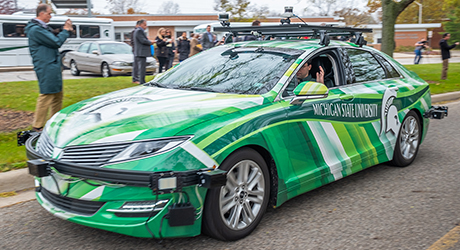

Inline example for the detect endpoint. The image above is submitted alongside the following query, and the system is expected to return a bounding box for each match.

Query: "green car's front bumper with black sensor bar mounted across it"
[22,134,226,238]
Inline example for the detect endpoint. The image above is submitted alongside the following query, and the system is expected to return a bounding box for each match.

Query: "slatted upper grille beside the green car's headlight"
[59,143,129,167]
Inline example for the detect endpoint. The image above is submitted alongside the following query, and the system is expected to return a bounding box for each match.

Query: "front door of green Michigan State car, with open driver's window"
[283,49,364,195]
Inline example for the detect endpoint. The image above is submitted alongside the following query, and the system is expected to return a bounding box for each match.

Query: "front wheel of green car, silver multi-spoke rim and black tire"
[203,148,270,241]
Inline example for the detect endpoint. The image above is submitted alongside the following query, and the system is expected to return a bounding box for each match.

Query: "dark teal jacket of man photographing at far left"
[25,19,69,94]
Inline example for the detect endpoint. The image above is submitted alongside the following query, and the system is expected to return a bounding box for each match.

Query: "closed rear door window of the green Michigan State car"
[347,49,386,82]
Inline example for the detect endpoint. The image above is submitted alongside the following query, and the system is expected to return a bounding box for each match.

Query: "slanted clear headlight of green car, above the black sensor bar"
[109,136,191,162]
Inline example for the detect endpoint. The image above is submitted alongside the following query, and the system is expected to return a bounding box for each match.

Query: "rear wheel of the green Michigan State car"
[391,110,422,167]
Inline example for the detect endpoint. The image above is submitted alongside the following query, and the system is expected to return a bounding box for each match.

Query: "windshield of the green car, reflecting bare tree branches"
[153,46,302,94]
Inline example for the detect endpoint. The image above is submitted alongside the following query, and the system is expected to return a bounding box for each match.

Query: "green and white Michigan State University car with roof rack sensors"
[26,28,447,240]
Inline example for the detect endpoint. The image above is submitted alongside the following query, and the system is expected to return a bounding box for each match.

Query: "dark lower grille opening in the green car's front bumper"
[40,187,105,216]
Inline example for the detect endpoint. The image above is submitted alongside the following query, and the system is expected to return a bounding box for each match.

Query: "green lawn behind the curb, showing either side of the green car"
[0,63,460,172]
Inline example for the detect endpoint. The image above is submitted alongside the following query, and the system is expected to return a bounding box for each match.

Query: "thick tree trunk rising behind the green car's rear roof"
[368,0,414,56]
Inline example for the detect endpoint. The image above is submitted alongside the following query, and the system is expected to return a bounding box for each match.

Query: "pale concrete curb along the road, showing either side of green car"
[0,91,460,208]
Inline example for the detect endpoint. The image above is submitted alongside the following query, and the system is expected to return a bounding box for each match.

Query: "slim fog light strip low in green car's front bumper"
[107,200,169,217]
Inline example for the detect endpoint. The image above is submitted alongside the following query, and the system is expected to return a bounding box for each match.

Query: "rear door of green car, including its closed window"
[344,48,402,167]
